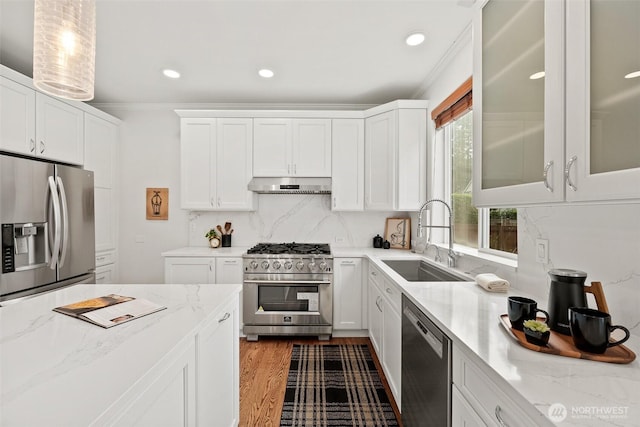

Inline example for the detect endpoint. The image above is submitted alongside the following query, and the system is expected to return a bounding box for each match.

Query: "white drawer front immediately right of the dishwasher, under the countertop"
[453,348,547,427]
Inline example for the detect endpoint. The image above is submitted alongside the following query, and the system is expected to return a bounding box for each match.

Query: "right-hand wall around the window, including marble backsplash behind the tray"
[412,37,640,333]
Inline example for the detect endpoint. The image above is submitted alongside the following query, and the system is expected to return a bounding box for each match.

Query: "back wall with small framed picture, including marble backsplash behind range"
[101,105,405,283]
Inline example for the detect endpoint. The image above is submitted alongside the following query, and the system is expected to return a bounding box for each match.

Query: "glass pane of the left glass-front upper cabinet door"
[482,0,545,189]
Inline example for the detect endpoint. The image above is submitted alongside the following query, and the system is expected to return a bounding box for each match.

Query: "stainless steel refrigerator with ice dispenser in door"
[0,155,95,301]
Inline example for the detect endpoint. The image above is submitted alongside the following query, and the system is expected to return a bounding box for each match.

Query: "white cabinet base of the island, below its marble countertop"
[97,297,240,427]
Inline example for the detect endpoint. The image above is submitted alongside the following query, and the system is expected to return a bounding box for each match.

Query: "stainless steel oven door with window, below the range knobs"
[243,280,333,326]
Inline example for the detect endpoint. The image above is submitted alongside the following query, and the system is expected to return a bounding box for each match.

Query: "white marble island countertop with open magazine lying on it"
[0,284,241,427]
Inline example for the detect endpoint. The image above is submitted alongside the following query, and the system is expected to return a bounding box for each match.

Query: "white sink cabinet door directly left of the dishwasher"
[382,299,402,407]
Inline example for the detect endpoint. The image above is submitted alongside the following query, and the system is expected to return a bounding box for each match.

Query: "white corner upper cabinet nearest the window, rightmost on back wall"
[364,101,427,211]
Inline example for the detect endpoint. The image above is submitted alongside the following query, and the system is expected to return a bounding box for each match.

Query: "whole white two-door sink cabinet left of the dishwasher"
[368,265,402,408]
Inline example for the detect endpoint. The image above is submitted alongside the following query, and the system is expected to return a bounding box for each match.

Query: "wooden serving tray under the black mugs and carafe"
[500,314,636,363]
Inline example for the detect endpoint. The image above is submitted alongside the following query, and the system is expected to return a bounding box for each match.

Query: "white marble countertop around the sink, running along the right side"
[362,252,640,426]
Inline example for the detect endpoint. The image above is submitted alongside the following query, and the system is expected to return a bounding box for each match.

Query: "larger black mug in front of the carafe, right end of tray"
[569,307,629,353]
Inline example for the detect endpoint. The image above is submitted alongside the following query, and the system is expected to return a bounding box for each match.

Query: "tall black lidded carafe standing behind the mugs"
[547,268,587,335]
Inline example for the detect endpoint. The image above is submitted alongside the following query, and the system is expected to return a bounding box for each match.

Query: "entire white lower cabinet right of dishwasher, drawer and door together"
[452,345,553,427]
